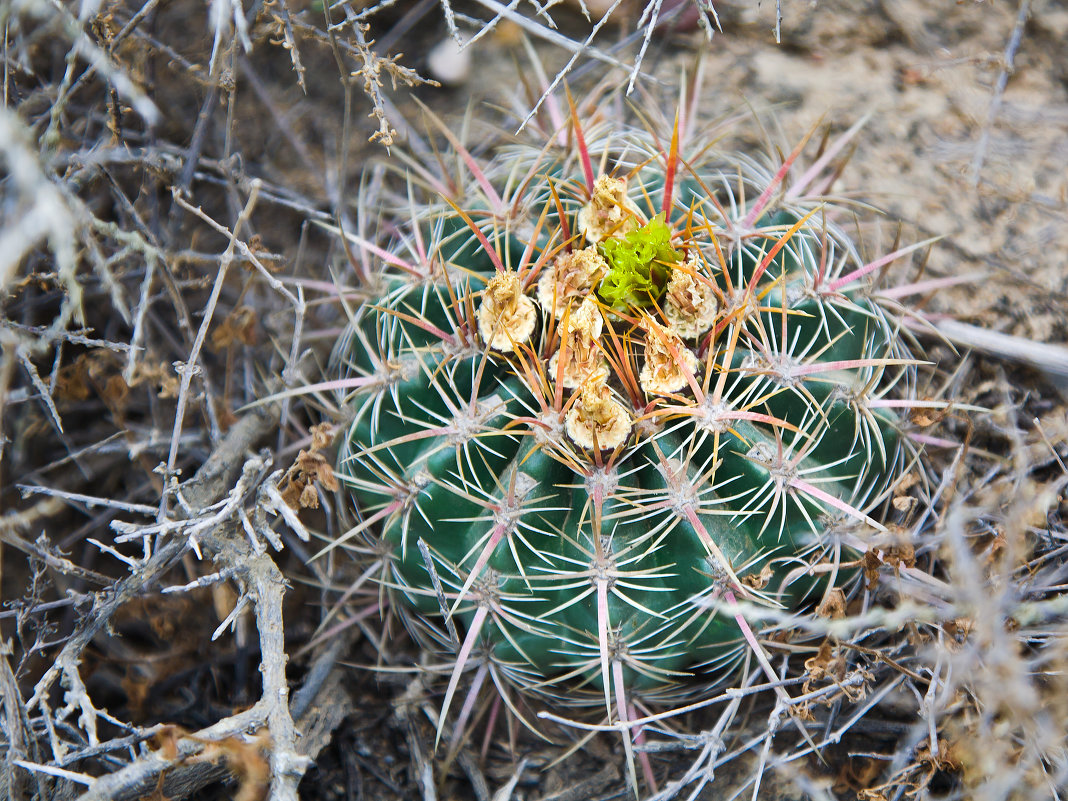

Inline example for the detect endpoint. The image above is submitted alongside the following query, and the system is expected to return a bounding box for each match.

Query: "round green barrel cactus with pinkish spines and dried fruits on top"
[339,125,911,705]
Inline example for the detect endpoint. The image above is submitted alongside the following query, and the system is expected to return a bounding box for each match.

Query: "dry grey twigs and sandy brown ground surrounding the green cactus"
[0,0,1068,801]
